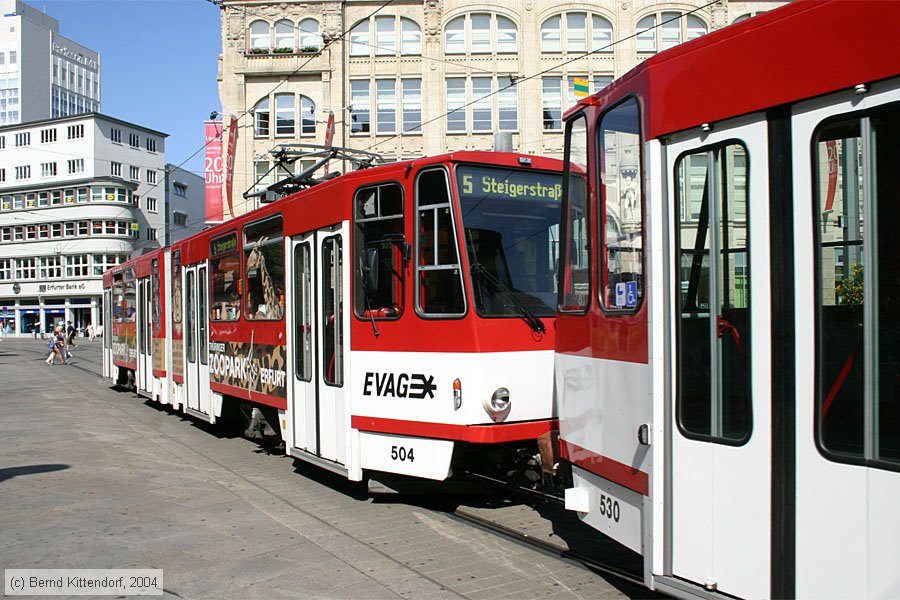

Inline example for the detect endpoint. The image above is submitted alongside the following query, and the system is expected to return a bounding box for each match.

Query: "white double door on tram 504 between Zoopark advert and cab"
[291,229,349,465]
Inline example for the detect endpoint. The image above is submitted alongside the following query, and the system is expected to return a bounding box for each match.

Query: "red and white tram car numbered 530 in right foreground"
[556,0,900,598]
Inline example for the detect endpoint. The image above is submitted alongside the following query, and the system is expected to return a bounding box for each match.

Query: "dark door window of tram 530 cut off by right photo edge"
[813,104,900,469]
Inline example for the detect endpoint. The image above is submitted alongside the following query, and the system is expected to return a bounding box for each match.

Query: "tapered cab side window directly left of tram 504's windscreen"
[416,169,466,316]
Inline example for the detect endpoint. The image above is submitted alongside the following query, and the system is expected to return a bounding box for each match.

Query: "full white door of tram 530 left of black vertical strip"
[666,118,771,598]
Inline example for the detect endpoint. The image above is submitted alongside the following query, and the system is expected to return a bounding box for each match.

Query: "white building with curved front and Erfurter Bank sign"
[0,114,169,335]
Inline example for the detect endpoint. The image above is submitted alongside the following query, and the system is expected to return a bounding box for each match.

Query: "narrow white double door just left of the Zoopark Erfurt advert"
[184,265,210,418]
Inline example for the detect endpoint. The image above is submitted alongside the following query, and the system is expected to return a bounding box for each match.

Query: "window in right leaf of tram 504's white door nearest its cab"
[322,235,344,386]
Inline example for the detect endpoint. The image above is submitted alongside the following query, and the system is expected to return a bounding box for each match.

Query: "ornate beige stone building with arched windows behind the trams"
[219,0,784,214]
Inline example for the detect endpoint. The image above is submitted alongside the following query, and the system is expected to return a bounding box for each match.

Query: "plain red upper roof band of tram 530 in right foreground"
[567,0,900,138]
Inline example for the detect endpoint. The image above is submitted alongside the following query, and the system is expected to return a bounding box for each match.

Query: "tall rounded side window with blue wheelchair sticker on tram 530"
[598,98,644,313]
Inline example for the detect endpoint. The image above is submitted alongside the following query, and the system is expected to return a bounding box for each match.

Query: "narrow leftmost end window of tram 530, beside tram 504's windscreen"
[558,116,591,312]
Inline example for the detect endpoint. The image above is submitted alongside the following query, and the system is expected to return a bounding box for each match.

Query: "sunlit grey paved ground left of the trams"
[0,338,649,600]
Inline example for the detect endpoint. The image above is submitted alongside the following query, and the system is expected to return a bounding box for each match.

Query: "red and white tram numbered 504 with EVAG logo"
[104,152,562,480]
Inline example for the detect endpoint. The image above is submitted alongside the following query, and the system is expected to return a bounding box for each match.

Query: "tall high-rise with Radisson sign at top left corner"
[0,0,100,126]
